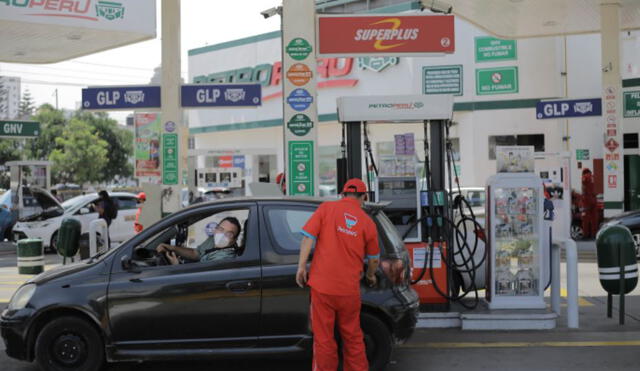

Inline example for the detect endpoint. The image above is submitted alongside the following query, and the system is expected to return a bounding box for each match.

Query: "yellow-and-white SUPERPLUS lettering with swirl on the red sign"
[354,18,420,50]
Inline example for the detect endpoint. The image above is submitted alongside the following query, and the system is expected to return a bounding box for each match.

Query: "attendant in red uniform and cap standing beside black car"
[296,178,380,371]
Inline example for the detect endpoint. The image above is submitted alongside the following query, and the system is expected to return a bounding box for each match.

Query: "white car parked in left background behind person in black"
[13,192,138,251]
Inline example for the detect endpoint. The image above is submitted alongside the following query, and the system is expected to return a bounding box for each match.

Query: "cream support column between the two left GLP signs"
[161,0,189,213]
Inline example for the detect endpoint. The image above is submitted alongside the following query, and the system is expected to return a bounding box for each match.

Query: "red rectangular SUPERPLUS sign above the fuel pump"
[317,14,455,57]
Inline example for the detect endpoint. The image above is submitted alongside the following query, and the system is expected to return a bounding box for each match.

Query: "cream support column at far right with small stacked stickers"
[600,0,624,217]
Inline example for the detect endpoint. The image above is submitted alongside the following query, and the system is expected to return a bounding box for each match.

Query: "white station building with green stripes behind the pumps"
[189,5,640,209]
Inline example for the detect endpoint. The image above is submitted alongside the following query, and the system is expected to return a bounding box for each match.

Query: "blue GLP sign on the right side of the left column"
[181,84,262,107]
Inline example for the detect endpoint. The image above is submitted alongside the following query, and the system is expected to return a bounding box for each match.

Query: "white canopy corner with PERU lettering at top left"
[0,0,156,63]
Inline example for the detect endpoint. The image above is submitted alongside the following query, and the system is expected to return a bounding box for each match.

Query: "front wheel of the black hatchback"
[35,317,104,371]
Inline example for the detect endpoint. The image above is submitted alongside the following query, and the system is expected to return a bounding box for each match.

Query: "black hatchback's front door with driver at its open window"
[108,203,261,352]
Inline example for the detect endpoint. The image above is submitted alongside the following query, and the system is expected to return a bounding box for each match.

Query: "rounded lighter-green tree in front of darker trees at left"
[49,118,108,184]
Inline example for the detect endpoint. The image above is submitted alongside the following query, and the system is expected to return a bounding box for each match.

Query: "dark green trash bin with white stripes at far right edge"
[596,225,638,295]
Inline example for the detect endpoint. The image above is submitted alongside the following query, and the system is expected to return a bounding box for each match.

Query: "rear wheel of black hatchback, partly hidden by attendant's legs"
[360,313,393,371]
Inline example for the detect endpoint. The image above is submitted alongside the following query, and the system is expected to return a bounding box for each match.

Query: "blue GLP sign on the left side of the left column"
[82,85,160,110]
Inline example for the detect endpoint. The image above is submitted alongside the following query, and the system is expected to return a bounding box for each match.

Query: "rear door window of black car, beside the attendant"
[267,207,315,254]
